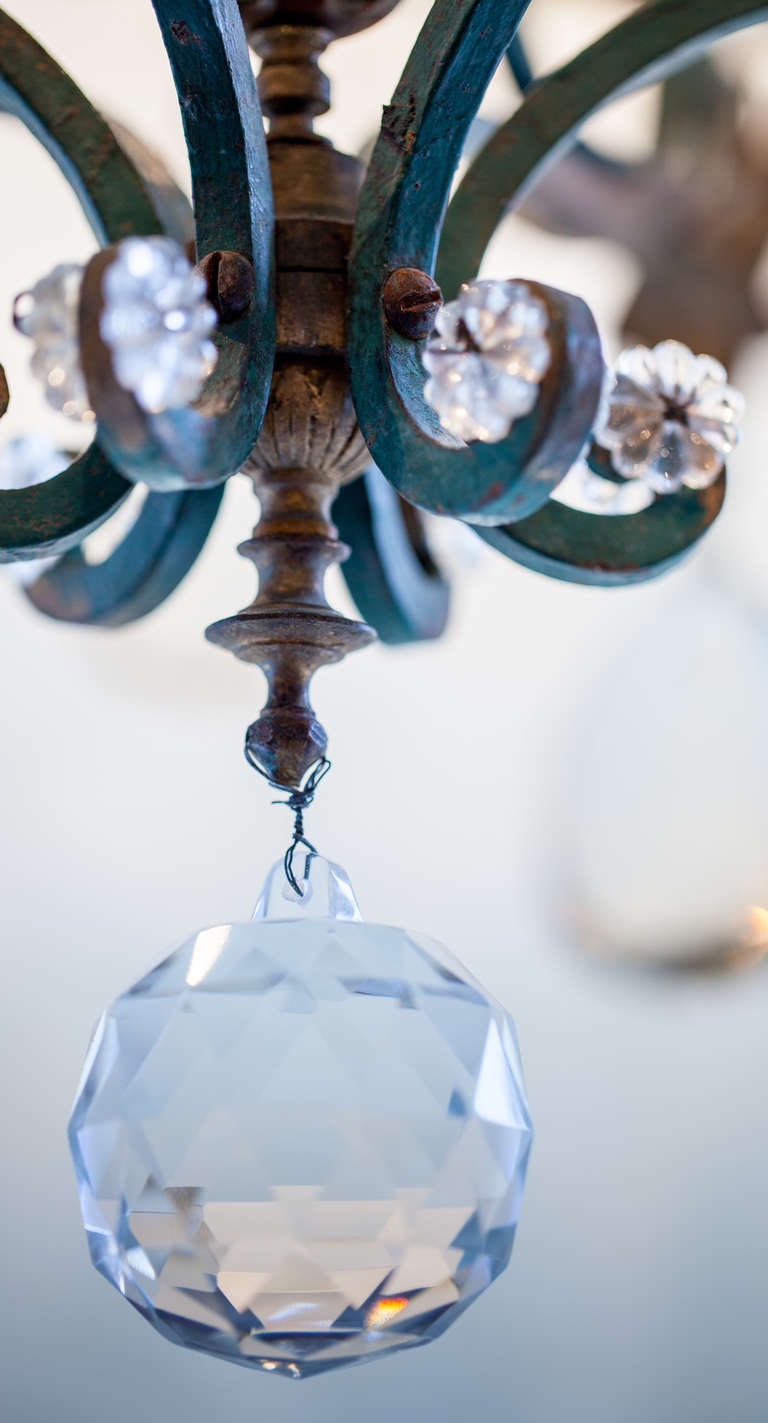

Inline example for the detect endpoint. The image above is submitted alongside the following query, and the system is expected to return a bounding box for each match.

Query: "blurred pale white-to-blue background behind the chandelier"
[0,0,768,1423]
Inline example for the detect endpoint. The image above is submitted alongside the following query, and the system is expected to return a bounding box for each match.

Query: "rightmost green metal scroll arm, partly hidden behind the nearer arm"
[437,0,768,583]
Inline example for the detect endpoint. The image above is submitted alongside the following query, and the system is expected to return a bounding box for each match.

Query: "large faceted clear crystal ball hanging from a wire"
[70,855,532,1377]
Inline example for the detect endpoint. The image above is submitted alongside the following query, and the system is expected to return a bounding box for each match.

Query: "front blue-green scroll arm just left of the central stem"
[84,0,274,490]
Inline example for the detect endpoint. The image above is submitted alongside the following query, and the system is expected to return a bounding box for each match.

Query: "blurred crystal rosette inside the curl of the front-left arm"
[101,236,216,414]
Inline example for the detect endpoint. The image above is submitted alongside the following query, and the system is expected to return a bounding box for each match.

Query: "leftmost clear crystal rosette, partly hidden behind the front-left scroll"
[14,262,94,420]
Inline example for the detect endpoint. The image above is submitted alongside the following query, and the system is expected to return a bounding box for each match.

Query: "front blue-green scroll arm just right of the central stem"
[348,0,603,524]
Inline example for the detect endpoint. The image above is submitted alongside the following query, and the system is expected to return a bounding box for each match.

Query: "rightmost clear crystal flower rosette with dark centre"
[594,342,744,494]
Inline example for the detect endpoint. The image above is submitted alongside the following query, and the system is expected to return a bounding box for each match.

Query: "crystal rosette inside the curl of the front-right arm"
[422,282,552,444]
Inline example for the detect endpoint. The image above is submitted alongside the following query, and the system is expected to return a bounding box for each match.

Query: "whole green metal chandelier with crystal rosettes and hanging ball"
[0,0,768,1377]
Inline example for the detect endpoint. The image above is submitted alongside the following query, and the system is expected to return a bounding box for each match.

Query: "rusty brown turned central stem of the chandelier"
[206,13,374,790]
